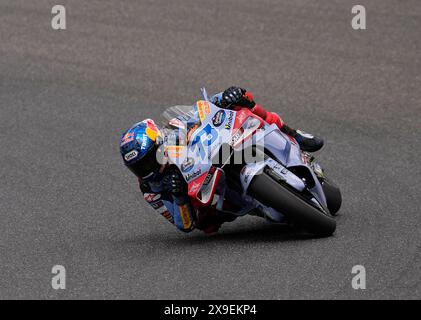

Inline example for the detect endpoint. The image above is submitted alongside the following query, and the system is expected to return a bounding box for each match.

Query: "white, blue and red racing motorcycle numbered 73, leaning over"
[161,88,342,236]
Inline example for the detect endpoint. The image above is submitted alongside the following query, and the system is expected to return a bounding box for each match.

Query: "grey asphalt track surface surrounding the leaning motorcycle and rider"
[0,0,421,299]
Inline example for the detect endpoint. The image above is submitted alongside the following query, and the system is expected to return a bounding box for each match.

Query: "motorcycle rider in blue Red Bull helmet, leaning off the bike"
[120,87,323,233]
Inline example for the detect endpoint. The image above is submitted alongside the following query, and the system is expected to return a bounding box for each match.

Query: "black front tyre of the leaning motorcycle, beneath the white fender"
[248,172,336,237]
